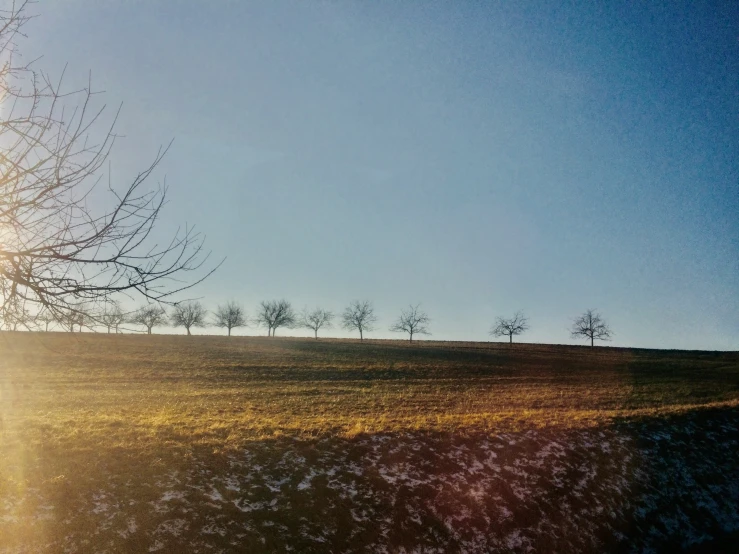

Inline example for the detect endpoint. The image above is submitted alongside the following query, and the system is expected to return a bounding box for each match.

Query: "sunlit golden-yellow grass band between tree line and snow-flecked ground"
[0,333,739,552]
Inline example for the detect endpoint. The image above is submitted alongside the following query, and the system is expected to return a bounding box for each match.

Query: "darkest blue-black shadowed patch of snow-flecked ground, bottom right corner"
[612,408,739,553]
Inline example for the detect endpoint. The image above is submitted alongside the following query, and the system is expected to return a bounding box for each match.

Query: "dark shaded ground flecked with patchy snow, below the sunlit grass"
[0,411,739,552]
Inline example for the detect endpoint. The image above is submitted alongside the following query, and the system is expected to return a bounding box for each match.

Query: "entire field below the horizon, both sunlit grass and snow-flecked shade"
[0,333,739,553]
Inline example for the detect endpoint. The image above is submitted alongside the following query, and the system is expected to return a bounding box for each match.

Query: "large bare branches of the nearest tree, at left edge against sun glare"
[0,1,220,330]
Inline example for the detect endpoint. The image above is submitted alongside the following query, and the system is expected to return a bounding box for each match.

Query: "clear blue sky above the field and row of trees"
[19,0,739,350]
